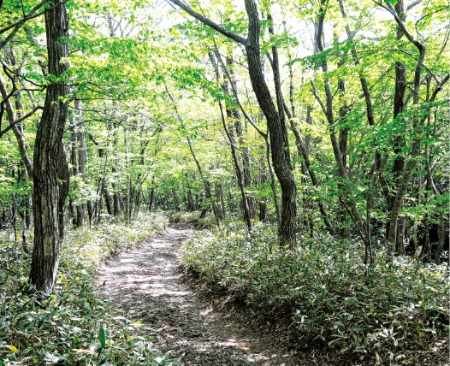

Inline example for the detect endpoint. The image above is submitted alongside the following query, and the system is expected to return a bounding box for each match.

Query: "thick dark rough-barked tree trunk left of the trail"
[30,3,69,294]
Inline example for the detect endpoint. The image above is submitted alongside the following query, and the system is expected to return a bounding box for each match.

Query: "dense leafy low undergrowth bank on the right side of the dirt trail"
[181,225,449,365]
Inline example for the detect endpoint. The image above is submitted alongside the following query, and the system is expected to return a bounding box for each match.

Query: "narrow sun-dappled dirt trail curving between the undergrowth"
[96,227,315,366]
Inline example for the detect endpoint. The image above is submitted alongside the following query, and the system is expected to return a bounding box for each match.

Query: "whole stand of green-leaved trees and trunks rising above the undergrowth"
[0,0,450,292]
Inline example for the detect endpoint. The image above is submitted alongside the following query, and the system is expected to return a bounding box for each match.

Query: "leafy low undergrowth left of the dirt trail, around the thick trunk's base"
[0,215,178,365]
